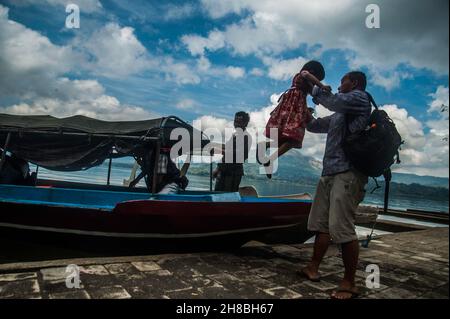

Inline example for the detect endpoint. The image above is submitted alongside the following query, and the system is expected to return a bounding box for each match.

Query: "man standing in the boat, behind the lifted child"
[213,112,252,192]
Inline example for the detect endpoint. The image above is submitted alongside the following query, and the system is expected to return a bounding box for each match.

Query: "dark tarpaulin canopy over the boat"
[0,114,209,171]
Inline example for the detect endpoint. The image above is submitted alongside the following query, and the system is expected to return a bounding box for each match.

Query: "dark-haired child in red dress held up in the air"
[256,61,331,178]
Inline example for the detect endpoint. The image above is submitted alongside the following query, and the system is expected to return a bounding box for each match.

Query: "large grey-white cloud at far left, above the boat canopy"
[0,5,155,120]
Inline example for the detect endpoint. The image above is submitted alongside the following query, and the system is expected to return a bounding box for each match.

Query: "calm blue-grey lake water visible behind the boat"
[32,163,449,213]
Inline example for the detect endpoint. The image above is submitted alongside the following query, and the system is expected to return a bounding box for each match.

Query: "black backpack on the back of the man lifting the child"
[343,93,403,178]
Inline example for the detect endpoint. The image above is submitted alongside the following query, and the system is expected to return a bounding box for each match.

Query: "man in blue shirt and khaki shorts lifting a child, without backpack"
[300,72,373,299]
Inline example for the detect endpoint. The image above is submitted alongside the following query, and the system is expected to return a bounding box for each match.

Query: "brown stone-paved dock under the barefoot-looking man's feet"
[0,228,449,299]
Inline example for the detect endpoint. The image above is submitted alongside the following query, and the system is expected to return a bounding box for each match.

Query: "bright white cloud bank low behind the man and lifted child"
[195,87,449,177]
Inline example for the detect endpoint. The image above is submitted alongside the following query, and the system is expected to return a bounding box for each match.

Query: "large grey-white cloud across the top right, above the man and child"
[191,0,449,87]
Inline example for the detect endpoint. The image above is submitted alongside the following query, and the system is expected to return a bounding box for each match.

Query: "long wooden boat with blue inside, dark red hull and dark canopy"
[0,115,311,247]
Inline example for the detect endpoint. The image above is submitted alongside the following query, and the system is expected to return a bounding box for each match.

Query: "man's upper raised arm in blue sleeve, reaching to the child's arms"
[312,86,370,115]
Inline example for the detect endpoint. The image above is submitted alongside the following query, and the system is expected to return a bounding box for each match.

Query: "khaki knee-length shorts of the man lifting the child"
[308,169,368,244]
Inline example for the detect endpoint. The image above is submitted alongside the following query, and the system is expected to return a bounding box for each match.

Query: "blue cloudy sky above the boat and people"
[0,0,449,177]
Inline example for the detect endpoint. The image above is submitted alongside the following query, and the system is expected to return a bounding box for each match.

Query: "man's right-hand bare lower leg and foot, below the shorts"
[332,240,359,299]
